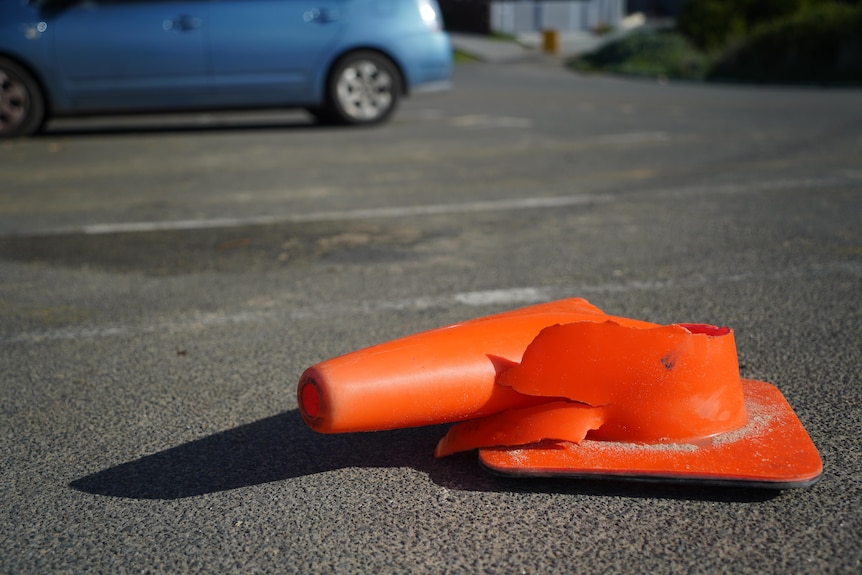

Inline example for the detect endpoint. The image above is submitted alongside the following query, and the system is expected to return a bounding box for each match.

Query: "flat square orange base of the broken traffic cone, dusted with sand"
[479,379,823,489]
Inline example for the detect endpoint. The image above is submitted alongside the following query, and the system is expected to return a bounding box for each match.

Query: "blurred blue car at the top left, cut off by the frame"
[0,0,452,137]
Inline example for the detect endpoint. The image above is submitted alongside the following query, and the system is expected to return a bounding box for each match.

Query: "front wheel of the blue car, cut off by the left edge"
[0,57,45,138]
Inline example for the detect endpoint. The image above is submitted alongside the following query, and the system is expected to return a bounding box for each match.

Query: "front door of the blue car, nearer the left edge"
[48,0,210,110]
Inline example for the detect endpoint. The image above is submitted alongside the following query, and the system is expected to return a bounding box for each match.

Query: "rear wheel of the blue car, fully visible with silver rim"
[326,51,402,125]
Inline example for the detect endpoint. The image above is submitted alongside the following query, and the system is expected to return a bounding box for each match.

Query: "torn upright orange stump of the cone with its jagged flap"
[436,321,747,456]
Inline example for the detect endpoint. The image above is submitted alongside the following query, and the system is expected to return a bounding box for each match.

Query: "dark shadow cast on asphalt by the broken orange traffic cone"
[70,410,778,501]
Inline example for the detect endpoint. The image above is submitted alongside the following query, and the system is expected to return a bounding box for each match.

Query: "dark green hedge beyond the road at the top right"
[570,0,862,85]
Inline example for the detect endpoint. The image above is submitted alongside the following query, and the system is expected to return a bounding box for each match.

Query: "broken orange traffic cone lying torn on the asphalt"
[297,299,822,487]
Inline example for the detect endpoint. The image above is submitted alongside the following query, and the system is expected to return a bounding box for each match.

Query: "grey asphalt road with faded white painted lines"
[0,62,862,574]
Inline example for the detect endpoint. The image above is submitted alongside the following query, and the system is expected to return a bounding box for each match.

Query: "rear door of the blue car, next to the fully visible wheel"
[209,0,346,105]
